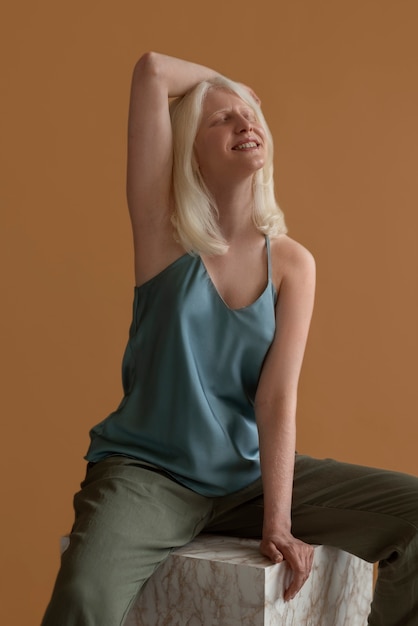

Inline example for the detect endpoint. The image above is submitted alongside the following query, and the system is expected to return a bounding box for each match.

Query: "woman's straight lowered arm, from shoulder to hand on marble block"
[255,237,315,600]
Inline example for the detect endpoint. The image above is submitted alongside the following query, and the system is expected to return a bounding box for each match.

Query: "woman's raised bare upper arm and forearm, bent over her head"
[127,52,216,283]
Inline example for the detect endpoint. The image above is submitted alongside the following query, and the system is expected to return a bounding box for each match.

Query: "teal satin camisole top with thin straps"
[86,238,277,496]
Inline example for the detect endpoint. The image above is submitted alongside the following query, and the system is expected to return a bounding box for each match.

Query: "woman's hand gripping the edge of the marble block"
[260,533,314,601]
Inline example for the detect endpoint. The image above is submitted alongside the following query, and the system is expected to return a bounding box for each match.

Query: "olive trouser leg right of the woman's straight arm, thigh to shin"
[292,456,418,626]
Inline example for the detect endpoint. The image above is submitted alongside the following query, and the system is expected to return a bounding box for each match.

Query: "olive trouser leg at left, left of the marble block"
[42,457,212,626]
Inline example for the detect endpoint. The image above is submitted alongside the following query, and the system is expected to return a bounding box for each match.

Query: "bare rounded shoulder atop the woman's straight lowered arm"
[271,235,315,287]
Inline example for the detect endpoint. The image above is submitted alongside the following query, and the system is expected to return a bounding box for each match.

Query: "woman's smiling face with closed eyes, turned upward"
[195,88,266,186]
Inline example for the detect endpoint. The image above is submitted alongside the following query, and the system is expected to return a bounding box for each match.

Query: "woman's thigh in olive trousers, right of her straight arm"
[292,455,418,562]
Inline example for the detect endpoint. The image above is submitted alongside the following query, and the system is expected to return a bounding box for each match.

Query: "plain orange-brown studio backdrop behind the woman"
[0,0,418,626]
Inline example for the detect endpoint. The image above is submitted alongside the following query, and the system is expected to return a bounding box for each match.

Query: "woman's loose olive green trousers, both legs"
[42,455,418,626]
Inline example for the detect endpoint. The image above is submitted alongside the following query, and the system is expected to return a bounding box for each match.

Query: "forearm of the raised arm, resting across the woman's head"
[134,52,219,97]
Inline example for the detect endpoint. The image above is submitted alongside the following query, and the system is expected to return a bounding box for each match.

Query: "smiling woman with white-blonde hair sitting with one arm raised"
[43,53,418,626]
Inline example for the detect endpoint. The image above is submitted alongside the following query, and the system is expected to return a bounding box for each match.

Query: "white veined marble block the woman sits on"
[125,535,373,626]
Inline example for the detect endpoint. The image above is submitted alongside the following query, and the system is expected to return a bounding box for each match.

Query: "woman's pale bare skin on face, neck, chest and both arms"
[127,53,315,600]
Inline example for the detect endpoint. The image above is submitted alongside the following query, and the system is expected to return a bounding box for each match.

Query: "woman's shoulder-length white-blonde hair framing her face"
[170,77,287,255]
